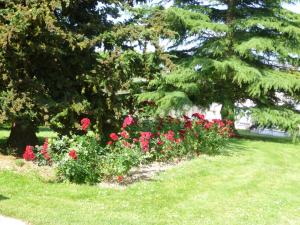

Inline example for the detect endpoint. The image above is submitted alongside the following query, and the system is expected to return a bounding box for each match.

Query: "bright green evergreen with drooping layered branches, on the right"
[140,0,300,135]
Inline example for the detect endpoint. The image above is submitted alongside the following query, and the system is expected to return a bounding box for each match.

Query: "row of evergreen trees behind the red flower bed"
[0,0,300,153]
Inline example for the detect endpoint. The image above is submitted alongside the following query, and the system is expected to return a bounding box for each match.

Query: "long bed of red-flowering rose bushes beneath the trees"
[23,113,233,183]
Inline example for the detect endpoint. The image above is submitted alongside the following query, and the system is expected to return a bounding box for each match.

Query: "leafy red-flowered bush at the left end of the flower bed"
[24,119,106,184]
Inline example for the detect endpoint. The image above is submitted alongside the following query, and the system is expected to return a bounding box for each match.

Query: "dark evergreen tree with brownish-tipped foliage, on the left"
[0,0,169,153]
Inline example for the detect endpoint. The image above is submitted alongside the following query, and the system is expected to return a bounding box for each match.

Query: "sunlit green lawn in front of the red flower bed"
[0,139,300,225]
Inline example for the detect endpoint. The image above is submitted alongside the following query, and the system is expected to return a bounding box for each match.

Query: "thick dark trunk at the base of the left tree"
[7,120,38,156]
